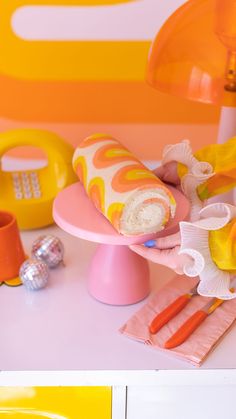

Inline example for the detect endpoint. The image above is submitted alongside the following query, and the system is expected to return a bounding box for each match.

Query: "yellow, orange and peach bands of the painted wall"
[0,0,219,159]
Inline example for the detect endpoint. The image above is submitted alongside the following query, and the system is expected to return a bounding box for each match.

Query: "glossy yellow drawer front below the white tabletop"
[0,387,112,419]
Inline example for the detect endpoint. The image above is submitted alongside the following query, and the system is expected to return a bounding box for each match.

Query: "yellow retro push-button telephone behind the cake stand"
[0,129,77,229]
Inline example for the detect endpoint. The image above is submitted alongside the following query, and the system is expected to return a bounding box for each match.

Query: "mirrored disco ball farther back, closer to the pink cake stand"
[32,236,64,268]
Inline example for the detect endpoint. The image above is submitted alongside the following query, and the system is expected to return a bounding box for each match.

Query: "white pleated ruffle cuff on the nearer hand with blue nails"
[179,203,236,300]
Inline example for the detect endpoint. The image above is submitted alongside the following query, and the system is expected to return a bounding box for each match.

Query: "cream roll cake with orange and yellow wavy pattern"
[73,134,176,236]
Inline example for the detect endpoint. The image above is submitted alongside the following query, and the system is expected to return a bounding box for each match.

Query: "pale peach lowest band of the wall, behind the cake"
[0,120,217,160]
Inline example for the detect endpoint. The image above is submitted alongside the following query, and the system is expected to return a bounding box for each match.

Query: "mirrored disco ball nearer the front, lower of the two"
[19,259,49,291]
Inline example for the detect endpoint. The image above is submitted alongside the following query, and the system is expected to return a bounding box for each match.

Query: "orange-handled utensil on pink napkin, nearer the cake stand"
[149,285,197,334]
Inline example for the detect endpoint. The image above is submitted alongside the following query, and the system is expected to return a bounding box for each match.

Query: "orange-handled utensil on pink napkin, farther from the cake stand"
[164,298,225,349]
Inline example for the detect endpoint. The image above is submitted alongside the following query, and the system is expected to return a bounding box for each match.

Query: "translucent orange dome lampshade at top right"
[147,0,236,104]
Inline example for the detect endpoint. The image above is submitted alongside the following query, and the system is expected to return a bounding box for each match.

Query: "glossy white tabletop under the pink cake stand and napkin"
[0,226,236,372]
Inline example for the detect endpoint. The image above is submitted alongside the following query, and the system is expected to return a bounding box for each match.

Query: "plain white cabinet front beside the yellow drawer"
[127,384,236,419]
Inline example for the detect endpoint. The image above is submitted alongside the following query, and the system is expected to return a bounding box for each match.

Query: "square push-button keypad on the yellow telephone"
[12,172,41,200]
